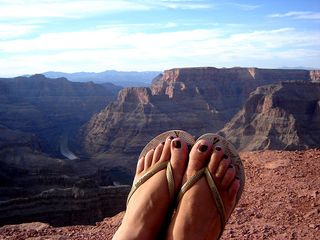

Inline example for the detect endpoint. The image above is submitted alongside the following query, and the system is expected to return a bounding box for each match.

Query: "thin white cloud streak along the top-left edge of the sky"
[0,0,212,19]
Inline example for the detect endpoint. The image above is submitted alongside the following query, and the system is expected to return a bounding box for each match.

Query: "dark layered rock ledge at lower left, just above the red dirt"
[0,186,130,226]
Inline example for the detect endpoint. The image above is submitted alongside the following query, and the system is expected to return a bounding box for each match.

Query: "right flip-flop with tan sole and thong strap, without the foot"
[177,133,245,239]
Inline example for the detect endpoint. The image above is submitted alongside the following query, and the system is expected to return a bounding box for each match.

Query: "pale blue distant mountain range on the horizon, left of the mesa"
[43,70,161,87]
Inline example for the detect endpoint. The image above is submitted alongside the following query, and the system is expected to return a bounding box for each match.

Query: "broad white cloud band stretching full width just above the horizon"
[0,27,320,75]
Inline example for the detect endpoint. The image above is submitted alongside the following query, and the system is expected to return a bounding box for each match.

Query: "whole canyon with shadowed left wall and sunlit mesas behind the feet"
[0,67,320,229]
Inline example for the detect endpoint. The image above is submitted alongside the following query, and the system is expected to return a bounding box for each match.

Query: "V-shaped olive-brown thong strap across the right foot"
[177,167,226,239]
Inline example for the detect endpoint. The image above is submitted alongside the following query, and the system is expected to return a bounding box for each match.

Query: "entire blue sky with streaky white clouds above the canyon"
[0,0,320,77]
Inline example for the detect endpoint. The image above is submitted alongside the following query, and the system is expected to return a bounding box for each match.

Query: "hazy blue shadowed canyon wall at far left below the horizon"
[0,75,120,155]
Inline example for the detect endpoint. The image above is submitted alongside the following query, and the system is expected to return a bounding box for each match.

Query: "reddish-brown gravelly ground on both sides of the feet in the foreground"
[0,149,320,240]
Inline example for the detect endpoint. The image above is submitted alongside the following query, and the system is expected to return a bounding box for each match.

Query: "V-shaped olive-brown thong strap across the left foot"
[127,161,174,205]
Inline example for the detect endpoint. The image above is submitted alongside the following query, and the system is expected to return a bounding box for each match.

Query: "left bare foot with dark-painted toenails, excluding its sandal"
[113,137,188,240]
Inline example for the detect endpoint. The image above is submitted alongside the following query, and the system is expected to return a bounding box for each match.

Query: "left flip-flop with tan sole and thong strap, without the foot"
[127,130,195,205]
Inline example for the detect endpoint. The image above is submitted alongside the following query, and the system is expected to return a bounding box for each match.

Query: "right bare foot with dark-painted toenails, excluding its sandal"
[167,139,240,240]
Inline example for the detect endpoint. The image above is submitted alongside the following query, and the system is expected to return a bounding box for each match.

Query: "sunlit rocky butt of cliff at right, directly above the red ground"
[221,82,320,151]
